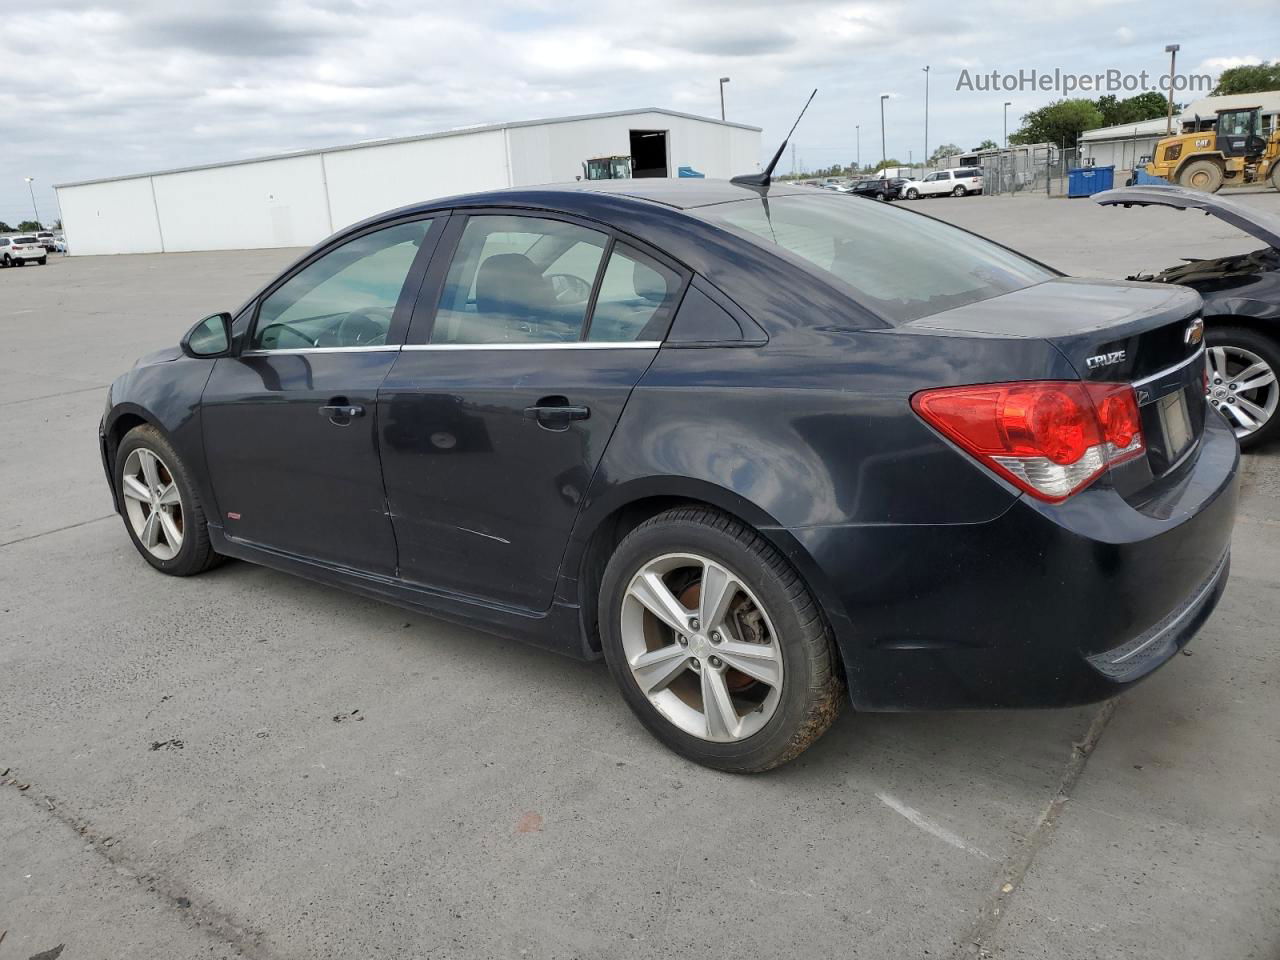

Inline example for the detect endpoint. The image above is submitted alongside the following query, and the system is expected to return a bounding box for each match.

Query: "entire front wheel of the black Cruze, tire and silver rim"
[115,425,220,576]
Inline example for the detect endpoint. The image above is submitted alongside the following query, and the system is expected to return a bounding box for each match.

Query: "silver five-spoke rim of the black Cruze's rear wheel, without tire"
[621,553,782,744]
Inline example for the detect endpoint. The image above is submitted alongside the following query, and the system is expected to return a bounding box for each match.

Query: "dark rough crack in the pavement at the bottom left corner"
[0,764,274,960]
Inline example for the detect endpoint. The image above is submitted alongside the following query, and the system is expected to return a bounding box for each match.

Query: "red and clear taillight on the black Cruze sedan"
[911,380,1144,503]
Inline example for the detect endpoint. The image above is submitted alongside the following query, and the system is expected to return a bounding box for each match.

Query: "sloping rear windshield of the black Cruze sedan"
[691,196,1057,324]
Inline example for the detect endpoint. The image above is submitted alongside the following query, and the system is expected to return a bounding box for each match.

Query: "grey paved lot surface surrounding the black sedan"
[0,193,1280,960]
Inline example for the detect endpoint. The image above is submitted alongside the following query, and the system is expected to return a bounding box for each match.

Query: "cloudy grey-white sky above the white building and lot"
[0,0,1280,224]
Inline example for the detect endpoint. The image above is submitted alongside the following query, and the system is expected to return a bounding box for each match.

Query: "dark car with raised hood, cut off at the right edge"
[1093,184,1280,449]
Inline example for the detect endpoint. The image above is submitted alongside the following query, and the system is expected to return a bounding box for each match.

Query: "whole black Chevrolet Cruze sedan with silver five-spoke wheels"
[101,180,1238,772]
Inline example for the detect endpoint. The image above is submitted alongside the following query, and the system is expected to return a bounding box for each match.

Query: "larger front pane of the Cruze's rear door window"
[431,215,609,344]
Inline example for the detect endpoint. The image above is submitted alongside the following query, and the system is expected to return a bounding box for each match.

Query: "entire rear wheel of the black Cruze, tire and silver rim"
[599,506,844,773]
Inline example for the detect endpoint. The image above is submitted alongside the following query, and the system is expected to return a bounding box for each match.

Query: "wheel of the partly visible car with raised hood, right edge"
[1204,326,1280,449]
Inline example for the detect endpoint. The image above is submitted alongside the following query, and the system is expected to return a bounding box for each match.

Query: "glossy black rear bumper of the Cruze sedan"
[790,415,1239,710]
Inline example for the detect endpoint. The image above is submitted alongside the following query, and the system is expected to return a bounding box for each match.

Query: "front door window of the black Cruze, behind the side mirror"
[251,220,433,349]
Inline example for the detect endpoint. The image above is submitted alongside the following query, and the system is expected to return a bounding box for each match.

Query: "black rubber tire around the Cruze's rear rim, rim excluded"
[599,506,845,773]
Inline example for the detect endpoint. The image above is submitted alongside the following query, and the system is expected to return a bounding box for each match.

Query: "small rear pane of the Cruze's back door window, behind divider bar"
[586,243,680,343]
